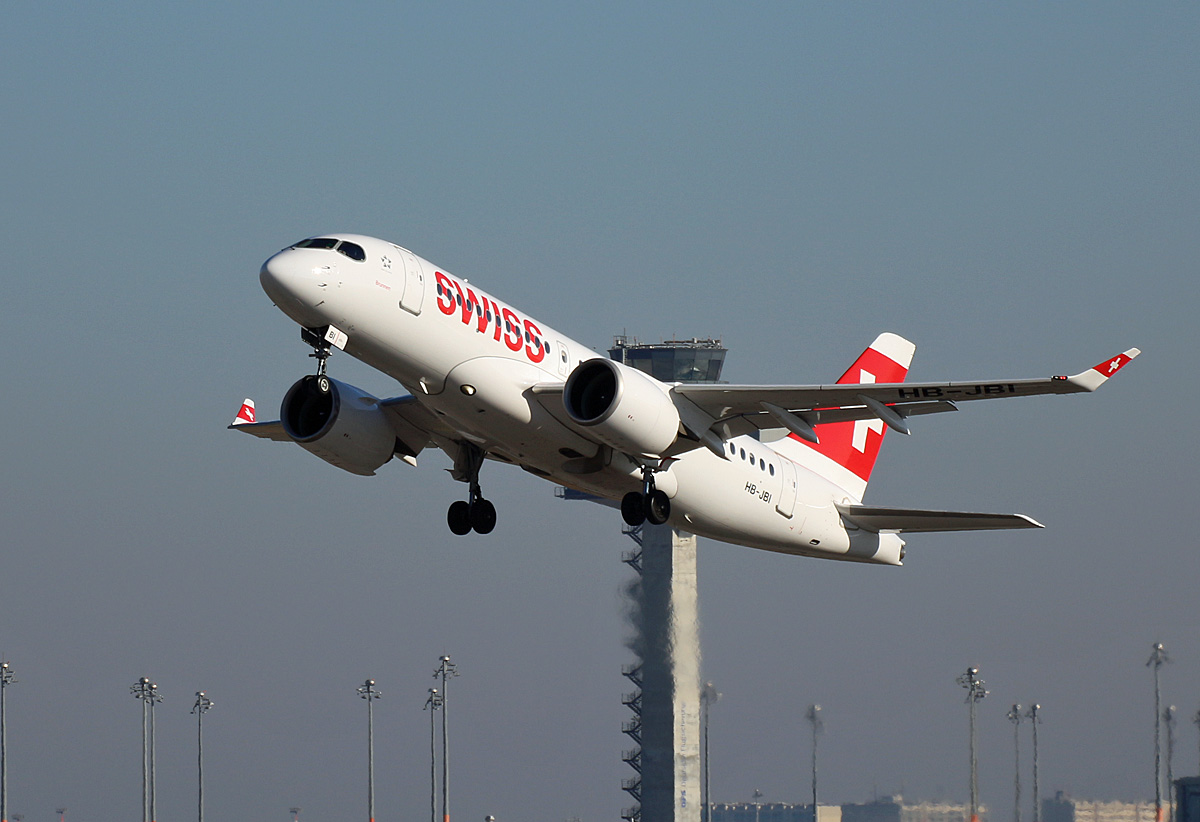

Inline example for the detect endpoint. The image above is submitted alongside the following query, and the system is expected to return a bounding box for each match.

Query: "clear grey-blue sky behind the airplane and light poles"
[0,1,1200,822]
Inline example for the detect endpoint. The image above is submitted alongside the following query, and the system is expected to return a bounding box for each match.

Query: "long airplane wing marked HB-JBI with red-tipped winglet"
[671,348,1141,430]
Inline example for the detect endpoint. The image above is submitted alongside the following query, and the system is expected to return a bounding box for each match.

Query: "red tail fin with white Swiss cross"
[772,334,917,502]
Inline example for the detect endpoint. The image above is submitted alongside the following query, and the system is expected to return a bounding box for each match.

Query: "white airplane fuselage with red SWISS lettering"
[260,234,902,564]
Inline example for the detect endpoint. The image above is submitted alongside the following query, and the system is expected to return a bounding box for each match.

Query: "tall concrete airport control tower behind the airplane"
[608,337,726,822]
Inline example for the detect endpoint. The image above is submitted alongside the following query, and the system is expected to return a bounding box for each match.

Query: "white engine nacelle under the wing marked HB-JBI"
[563,358,679,457]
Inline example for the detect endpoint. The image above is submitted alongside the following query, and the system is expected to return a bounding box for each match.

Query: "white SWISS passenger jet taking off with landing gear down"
[229,233,1140,565]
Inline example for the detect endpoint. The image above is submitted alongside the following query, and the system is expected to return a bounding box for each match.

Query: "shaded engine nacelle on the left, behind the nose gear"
[280,376,396,476]
